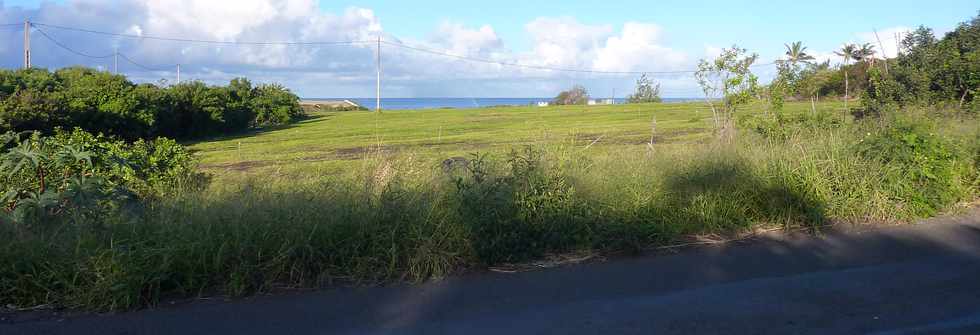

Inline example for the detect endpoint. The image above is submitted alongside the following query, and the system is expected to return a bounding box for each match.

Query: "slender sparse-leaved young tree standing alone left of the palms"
[694,45,759,135]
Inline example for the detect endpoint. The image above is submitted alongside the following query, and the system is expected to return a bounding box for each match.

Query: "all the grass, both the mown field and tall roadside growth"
[0,103,980,310]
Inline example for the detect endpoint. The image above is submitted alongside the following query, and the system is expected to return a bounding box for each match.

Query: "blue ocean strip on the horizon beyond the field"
[304,98,698,110]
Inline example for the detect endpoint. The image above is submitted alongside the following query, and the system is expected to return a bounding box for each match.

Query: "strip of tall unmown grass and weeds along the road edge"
[0,113,980,310]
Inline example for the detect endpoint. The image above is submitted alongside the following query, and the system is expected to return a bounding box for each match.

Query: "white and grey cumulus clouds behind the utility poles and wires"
[0,0,693,97]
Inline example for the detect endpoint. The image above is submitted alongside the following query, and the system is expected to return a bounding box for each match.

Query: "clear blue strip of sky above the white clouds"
[321,0,980,53]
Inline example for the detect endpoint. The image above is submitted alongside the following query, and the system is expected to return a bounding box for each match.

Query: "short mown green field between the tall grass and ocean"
[191,102,842,179]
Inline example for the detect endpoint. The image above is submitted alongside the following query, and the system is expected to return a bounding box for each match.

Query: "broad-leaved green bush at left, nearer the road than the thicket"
[0,129,207,223]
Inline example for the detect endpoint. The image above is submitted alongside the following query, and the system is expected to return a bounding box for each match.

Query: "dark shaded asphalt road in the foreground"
[0,212,980,335]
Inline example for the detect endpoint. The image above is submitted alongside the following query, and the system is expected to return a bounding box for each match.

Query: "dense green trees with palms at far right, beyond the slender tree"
[772,16,980,113]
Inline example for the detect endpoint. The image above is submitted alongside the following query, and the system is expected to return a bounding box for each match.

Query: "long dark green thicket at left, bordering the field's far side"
[0,68,303,140]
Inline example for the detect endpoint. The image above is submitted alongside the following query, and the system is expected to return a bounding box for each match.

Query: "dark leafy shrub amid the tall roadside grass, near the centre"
[456,147,589,264]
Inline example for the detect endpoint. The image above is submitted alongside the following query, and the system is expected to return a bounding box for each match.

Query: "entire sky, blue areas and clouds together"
[0,0,980,98]
